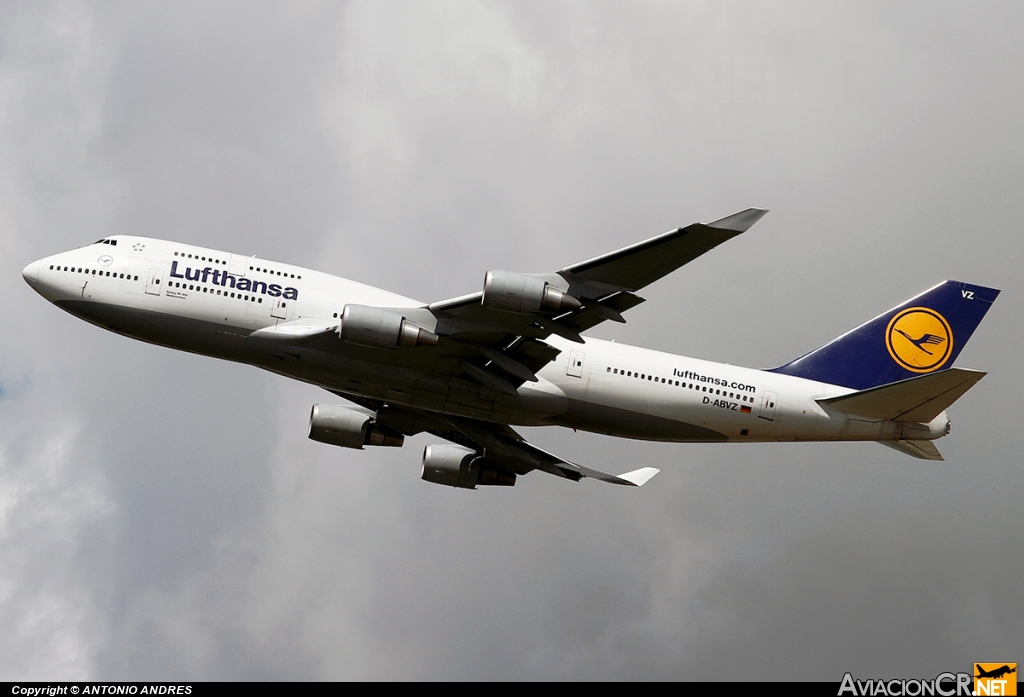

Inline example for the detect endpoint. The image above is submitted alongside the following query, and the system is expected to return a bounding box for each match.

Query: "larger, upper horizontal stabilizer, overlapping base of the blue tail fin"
[817,367,986,421]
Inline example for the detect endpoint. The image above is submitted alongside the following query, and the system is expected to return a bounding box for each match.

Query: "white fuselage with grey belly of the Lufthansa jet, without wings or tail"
[25,235,948,442]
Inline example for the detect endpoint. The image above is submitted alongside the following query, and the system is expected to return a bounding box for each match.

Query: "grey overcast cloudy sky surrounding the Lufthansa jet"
[0,0,1024,681]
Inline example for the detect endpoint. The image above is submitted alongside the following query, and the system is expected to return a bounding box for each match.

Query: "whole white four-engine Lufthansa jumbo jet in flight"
[23,208,999,489]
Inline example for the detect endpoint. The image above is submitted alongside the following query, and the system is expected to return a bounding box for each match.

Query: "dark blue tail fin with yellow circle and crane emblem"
[771,280,999,390]
